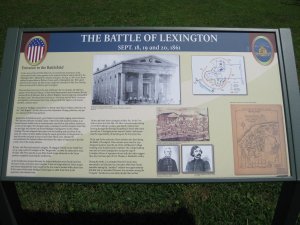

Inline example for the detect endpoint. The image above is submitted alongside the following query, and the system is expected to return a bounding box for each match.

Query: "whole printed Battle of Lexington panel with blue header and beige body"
[1,29,295,182]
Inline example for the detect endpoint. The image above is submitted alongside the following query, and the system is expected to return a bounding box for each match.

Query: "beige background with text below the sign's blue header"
[7,52,290,179]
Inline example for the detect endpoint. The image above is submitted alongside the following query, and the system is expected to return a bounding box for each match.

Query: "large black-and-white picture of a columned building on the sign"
[92,54,180,105]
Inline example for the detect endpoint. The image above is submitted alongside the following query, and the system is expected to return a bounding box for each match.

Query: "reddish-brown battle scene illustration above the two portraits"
[157,107,209,141]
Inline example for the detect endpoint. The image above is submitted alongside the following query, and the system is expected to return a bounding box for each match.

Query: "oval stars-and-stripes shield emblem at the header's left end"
[24,36,47,66]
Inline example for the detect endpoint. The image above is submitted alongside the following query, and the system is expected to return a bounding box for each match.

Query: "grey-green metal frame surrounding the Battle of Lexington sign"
[0,28,300,183]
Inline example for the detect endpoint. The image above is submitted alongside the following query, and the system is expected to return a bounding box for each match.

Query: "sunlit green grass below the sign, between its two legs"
[17,183,280,225]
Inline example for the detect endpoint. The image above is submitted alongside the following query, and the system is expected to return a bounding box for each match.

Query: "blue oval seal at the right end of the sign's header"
[252,36,274,66]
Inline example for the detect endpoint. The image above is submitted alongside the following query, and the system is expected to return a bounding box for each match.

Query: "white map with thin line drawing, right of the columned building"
[192,56,247,95]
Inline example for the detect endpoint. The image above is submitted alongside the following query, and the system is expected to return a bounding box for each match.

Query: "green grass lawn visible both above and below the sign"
[0,0,300,225]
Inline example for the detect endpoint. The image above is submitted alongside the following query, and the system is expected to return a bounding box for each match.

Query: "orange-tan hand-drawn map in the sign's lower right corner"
[231,104,288,175]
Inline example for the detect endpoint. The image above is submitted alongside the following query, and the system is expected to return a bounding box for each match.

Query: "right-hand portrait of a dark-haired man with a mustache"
[182,145,214,173]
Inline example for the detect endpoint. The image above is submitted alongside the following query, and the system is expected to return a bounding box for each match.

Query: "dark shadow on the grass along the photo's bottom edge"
[19,209,195,225]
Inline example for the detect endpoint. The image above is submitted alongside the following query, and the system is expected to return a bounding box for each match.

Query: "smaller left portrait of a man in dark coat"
[157,145,179,173]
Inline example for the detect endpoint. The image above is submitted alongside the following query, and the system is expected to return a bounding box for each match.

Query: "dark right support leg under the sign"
[272,181,300,225]
